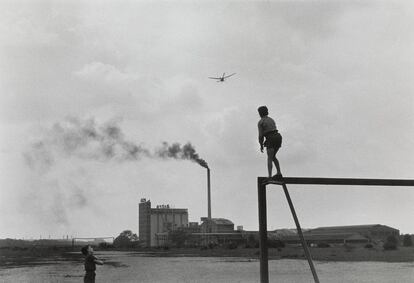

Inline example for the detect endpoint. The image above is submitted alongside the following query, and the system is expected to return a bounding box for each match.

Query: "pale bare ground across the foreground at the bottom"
[0,250,414,283]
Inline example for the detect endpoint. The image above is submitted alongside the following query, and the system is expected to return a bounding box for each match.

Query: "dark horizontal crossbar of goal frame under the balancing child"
[258,177,414,187]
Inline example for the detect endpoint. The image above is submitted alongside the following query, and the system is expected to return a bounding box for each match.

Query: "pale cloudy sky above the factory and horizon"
[0,0,414,238]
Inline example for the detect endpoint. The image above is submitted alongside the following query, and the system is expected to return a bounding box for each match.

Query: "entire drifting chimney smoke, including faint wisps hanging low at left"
[21,118,208,227]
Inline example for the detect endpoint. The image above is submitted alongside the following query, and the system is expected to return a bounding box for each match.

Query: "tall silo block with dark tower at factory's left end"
[138,199,188,247]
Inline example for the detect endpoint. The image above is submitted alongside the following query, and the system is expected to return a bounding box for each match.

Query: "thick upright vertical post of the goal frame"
[257,177,269,283]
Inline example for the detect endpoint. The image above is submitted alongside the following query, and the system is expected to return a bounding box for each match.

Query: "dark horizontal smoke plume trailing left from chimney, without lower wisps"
[24,118,208,172]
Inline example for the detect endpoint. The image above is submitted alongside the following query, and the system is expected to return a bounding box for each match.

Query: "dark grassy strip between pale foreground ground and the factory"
[0,246,414,267]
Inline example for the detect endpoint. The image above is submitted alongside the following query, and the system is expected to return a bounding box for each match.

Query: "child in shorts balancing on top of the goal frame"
[257,106,282,178]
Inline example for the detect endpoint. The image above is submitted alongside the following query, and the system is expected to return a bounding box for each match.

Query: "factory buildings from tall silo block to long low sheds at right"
[138,198,400,247]
